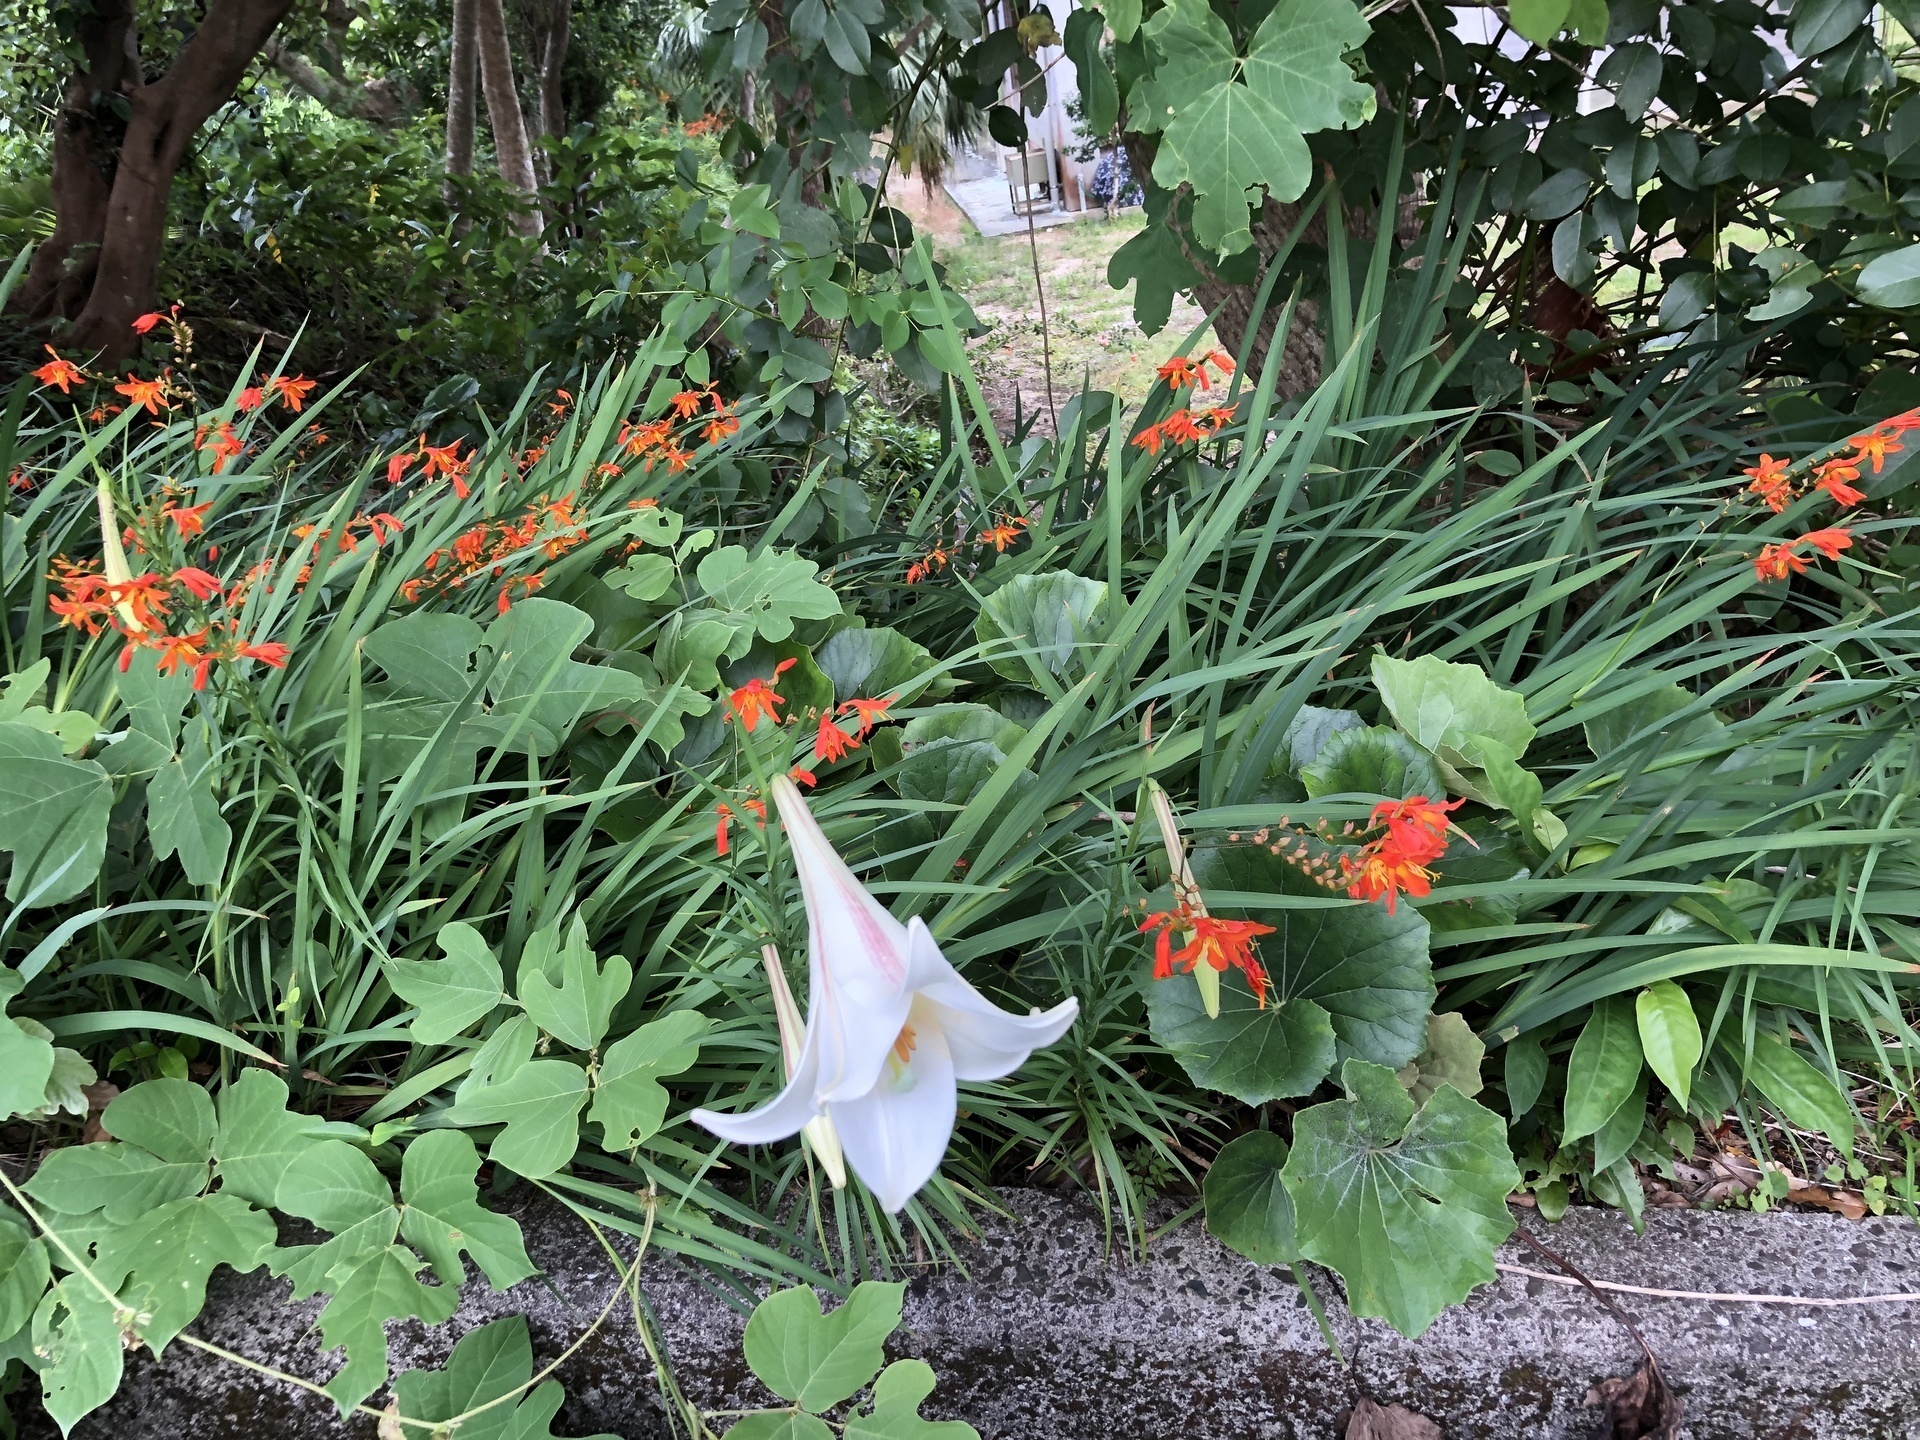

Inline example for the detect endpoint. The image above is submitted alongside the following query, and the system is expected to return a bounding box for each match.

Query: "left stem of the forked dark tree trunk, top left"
[10,0,140,323]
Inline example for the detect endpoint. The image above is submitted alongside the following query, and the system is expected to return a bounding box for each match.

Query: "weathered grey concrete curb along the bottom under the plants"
[25,1192,1920,1440]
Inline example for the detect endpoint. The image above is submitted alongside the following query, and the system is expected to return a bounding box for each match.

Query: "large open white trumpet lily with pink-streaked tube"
[693,776,1079,1212]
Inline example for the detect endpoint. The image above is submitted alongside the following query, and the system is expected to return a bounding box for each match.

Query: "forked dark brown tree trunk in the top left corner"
[12,0,292,363]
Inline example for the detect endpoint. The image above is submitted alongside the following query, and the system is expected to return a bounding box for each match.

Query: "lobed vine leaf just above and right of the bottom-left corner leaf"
[94,1194,278,1356]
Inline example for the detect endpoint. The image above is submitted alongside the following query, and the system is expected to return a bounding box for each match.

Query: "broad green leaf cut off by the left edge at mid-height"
[0,720,113,904]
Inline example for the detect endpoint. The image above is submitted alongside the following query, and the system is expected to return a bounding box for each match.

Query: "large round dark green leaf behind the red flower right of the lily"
[1146,845,1434,1104]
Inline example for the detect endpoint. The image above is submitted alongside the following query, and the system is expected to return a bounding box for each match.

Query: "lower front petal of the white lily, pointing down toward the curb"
[828,1004,958,1213]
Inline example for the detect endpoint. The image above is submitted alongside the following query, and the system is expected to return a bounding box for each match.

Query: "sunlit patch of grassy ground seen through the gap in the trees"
[887,177,1204,434]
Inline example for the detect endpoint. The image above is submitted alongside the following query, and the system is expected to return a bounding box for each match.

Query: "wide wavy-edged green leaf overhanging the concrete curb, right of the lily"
[1281,1060,1521,1336]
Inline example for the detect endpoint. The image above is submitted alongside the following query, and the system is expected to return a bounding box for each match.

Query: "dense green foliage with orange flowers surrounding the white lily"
[0,0,1920,1440]
